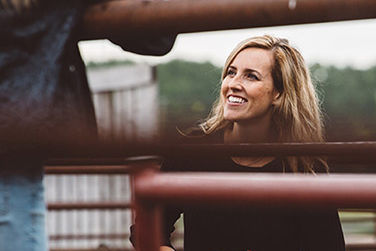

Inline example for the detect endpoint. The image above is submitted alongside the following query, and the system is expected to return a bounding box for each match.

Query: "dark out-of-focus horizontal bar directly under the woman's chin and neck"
[50,141,376,159]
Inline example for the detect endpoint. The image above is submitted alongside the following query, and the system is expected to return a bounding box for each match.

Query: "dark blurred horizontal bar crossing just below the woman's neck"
[47,141,376,164]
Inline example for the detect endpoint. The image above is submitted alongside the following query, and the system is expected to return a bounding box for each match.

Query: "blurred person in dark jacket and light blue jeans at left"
[0,0,175,251]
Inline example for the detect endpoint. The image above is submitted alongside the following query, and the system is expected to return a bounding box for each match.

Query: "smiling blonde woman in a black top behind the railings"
[131,35,345,251]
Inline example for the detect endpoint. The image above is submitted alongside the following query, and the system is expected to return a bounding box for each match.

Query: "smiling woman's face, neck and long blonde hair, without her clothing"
[201,36,327,172]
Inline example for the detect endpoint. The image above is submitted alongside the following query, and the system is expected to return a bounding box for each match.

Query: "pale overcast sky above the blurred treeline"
[79,19,376,69]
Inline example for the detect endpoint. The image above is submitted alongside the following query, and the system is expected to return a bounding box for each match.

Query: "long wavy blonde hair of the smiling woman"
[200,35,328,172]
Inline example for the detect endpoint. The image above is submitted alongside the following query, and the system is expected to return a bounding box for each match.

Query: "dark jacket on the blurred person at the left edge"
[0,0,175,159]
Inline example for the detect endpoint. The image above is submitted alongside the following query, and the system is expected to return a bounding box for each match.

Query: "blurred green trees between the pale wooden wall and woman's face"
[157,60,221,132]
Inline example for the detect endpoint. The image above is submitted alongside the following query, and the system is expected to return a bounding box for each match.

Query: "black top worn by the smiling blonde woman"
[162,157,345,251]
